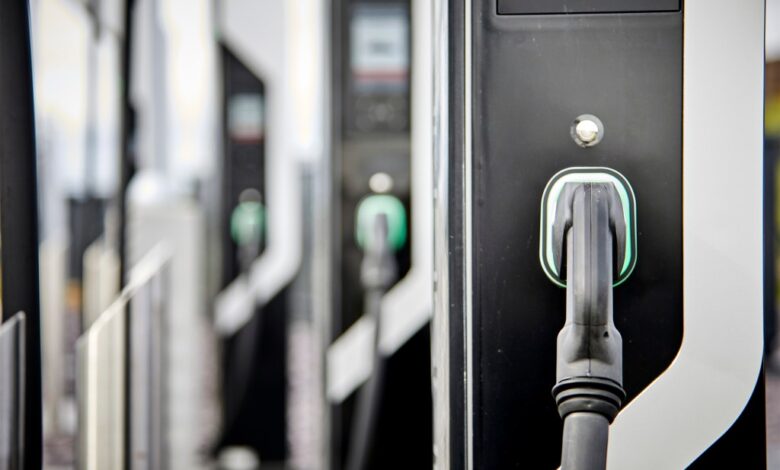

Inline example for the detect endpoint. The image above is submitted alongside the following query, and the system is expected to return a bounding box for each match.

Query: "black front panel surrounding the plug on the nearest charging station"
[470,8,683,469]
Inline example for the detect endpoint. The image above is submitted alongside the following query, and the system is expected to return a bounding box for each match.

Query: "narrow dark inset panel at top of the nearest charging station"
[498,0,680,15]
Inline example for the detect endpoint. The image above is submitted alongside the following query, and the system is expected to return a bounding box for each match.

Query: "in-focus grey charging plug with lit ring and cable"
[539,168,637,470]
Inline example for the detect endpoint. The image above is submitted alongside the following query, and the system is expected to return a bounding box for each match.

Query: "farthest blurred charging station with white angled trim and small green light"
[214,0,327,468]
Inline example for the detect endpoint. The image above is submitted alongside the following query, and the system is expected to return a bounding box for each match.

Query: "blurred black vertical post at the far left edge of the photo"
[0,0,43,470]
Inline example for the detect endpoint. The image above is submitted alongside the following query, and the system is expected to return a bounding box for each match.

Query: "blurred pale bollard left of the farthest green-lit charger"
[127,199,218,470]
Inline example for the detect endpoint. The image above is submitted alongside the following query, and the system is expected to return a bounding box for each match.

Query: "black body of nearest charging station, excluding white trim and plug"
[437,0,765,468]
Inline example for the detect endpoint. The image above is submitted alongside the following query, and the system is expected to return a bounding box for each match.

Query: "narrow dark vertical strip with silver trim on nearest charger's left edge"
[447,0,471,470]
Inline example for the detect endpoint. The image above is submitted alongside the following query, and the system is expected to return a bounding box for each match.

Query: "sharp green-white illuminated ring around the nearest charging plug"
[539,167,637,287]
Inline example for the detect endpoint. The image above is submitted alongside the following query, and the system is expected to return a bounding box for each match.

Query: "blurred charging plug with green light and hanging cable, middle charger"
[346,194,407,470]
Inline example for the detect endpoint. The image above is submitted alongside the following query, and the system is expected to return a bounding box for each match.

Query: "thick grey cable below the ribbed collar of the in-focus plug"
[561,411,609,470]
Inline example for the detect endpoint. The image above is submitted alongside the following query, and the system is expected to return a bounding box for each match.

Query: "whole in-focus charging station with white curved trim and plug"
[433,0,766,470]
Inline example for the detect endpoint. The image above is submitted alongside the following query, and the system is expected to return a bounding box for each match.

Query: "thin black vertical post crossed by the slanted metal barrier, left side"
[117,0,135,468]
